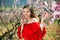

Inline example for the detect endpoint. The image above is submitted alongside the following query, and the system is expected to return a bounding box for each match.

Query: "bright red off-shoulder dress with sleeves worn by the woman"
[17,22,46,40]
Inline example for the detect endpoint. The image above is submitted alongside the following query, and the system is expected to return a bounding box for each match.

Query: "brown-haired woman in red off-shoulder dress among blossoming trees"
[17,5,46,40]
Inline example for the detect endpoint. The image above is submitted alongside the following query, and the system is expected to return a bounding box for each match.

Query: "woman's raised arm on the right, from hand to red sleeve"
[40,13,48,37]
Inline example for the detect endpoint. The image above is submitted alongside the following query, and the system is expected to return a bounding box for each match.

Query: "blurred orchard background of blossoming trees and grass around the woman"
[0,0,60,40]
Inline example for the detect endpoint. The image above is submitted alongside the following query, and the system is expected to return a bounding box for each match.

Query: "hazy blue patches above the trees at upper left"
[0,0,26,7]
